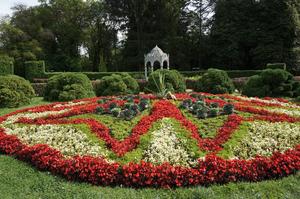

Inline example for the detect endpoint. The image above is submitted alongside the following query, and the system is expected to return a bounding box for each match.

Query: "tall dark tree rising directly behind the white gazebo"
[106,0,187,70]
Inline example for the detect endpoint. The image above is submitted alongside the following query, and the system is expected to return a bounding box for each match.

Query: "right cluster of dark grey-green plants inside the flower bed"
[180,96,234,119]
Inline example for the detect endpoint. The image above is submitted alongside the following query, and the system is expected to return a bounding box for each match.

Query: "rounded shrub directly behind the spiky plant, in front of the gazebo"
[145,69,186,93]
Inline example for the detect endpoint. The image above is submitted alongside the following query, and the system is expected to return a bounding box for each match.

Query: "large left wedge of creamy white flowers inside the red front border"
[4,124,106,157]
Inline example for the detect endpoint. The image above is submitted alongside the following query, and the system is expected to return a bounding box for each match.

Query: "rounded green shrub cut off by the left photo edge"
[0,75,35,108]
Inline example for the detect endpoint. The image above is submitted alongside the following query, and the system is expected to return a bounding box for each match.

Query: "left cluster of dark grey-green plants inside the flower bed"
[96,96,150,121]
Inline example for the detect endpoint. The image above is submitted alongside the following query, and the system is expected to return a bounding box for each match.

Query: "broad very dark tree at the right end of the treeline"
[211,0,296,69]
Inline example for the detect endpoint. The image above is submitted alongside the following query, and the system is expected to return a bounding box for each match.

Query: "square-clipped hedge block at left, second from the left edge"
[24,61,45,81]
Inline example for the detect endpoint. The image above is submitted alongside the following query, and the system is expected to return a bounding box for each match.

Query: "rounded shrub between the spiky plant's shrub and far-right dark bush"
[196,69,234,94]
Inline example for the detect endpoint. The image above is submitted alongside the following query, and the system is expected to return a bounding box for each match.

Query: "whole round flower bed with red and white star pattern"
[0,93,300,188]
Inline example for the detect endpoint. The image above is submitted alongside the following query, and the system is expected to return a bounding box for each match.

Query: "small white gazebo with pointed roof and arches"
[145,46,170,80]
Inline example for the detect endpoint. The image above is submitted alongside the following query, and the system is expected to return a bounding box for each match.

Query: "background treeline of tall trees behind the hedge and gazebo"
[0,0,300,76]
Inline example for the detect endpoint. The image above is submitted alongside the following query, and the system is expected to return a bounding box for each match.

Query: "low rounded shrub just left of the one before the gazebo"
[96,73,139,96]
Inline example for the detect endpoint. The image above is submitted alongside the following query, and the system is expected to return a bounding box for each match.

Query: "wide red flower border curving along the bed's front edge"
[0,133,300,188]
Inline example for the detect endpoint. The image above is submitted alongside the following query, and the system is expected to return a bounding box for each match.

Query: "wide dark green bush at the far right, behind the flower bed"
[242,69,299,97]
